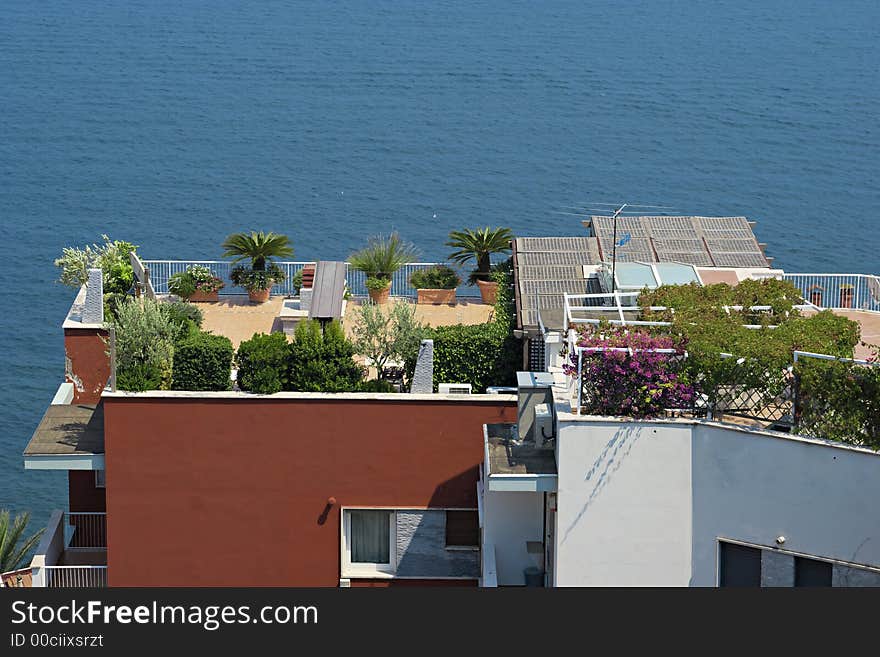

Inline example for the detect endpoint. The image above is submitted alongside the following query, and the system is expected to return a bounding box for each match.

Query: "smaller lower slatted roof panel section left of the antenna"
[515,237,601,328]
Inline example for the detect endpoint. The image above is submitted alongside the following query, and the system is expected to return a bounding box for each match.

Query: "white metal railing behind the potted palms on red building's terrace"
[143,260,465,297]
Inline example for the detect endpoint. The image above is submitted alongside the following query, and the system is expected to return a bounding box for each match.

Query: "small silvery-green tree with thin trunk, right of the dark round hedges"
[352,302,427,379]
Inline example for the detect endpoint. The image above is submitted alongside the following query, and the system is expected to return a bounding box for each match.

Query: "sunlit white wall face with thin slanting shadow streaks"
[555,417,691,586]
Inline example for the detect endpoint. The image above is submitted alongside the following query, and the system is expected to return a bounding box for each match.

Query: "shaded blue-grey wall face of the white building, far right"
[691,425,880,586]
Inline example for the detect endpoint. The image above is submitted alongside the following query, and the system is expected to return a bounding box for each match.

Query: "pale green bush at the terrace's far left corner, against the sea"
[55,235,137,293]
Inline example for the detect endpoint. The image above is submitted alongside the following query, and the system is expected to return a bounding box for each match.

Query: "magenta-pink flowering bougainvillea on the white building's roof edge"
[564,327,695,418]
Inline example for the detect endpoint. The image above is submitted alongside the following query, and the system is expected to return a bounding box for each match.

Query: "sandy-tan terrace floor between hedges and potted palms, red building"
[196,296,493,349]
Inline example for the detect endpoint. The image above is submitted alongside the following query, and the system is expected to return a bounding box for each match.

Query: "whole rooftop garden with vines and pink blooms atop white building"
[565,279,880,449]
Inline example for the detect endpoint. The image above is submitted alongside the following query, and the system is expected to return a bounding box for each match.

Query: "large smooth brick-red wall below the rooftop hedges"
[104,397,516,586]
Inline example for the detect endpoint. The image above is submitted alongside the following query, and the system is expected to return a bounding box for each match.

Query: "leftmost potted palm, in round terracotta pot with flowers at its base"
[223,231,293,303]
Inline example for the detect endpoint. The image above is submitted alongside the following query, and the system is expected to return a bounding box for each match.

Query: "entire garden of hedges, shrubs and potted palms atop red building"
[56,228,522,394]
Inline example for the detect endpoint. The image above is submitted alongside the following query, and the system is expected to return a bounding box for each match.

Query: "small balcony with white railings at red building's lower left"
[31,511,107,588]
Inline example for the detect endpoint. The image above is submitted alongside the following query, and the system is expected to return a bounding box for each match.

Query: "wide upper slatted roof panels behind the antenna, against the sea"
[589,216,769,267]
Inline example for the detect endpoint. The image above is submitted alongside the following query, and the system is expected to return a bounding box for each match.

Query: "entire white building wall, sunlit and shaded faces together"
[555,414,880,586]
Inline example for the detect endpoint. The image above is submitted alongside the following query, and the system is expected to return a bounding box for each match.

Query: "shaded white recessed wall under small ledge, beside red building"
[483,487,544,586]
